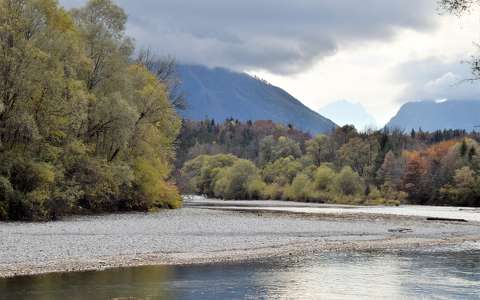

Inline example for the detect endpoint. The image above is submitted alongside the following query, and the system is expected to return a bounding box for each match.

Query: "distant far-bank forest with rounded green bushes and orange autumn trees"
[177,120,480,206]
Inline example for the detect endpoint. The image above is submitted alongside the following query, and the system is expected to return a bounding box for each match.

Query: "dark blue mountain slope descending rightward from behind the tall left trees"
[174,65,336,134]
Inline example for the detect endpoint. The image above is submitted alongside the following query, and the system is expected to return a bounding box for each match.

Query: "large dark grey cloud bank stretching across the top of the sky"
[60,0,436,74]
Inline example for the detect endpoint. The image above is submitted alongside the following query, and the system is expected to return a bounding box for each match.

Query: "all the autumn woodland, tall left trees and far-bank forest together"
[0,0,480,221]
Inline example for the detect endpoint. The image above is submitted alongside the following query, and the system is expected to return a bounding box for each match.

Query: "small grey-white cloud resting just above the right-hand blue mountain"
[396,58,480,102]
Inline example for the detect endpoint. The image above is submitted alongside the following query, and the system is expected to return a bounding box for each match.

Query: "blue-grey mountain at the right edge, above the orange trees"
[387,100,480,131]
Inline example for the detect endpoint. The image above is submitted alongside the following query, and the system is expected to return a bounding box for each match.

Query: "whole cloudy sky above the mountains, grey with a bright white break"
[60,0,480,125]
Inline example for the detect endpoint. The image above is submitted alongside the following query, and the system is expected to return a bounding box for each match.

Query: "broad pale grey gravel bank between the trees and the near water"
[0,201,480,277]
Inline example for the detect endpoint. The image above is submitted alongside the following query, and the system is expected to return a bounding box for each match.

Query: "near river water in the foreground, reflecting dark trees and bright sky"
[0,251,480,300]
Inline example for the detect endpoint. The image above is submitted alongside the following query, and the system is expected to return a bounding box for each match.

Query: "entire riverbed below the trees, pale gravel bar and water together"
[0,199,480,300]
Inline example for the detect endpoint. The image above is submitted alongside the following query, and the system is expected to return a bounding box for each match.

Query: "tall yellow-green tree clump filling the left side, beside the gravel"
[0,0,181,220]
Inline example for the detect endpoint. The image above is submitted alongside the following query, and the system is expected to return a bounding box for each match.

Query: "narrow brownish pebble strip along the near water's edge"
[0,235,480,279]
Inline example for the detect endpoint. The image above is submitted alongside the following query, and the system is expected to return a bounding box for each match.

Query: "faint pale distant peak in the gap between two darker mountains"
[318,100,377,130]
